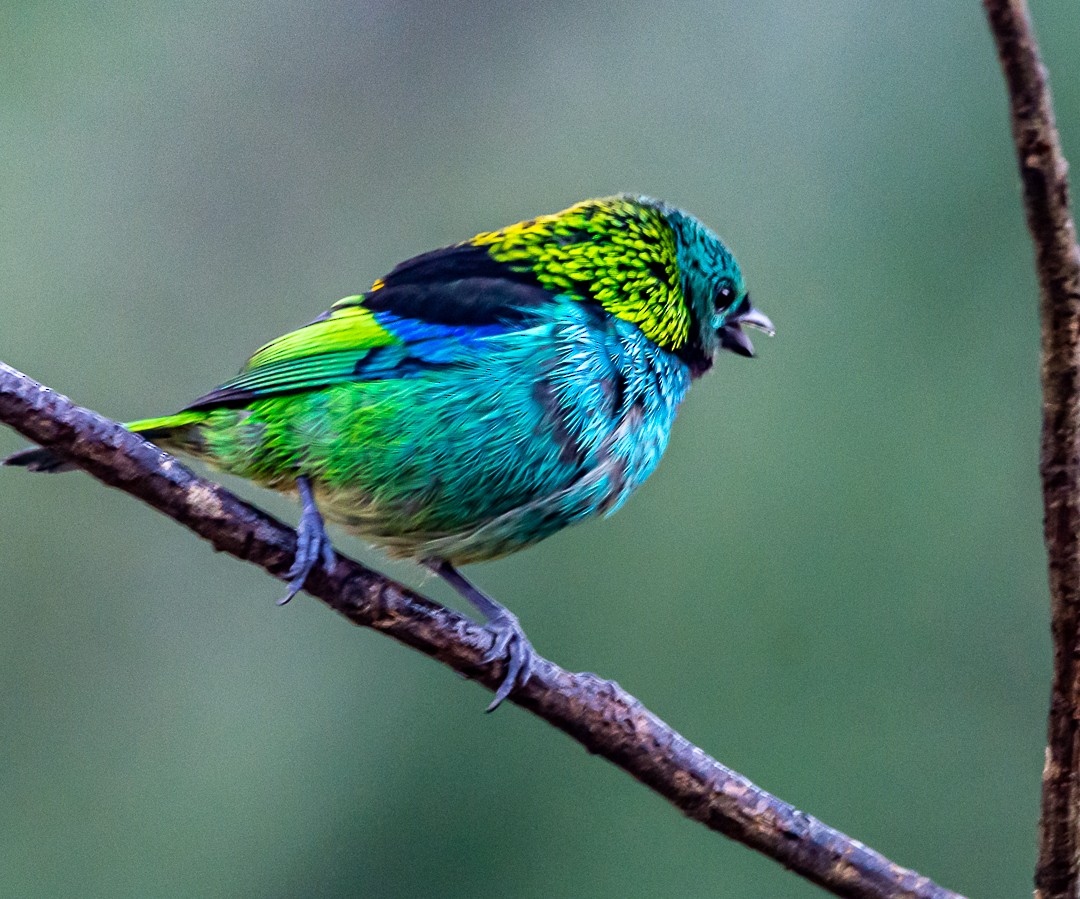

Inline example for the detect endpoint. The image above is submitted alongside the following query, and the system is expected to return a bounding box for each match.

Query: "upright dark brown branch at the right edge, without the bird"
[983,0,1080,899]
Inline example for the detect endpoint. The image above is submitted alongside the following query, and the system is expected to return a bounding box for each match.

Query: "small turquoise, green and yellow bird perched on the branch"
[4,194,774,711]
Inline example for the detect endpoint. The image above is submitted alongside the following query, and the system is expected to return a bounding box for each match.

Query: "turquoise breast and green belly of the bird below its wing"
[304,304,690,564]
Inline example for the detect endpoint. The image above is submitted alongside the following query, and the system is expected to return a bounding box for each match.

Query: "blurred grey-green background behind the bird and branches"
[0,0,1067,897]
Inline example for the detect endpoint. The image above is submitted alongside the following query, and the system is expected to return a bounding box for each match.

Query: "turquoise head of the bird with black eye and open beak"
[661,199,774,377]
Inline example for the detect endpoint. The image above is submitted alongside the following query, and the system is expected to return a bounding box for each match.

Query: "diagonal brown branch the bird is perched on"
[0,362,962,899]
